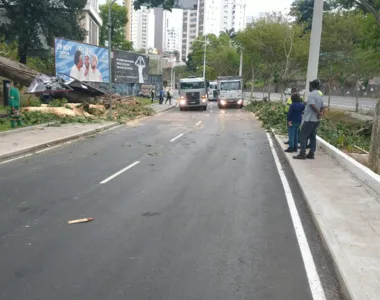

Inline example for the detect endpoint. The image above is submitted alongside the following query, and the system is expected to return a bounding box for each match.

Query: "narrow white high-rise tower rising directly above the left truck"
[181,9,198,60]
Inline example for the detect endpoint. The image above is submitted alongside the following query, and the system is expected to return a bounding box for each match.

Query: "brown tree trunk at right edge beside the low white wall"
[368,99,380,173]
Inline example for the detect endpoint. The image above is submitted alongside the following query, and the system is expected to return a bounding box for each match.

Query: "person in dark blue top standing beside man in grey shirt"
[285,93,305,153]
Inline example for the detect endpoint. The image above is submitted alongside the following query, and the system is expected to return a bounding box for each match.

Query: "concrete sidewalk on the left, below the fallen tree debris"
[0,102,176,161]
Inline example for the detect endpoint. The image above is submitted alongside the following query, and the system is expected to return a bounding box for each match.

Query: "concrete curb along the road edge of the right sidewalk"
[271,130,367,300]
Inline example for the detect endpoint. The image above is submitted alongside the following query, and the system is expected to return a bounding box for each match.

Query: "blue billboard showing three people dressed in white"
[54,38,109,82]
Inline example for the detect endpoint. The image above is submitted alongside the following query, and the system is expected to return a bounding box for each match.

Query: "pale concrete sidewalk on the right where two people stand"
[275,136,380,300]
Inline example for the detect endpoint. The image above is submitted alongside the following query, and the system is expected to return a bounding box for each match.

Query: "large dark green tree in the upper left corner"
[0,0,86,64]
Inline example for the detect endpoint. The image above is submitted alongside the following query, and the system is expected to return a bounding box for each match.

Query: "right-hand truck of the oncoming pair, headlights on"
[218,76,243,108]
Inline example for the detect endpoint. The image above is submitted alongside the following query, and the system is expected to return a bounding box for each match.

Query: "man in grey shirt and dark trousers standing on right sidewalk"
[293,79,324,159]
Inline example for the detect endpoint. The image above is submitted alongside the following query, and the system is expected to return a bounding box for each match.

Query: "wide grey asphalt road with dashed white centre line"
[0,103,341,300]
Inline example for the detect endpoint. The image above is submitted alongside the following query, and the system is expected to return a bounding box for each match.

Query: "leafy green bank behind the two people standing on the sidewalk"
[246,101,371,152]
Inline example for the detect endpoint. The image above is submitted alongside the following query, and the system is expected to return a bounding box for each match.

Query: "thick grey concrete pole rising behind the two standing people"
[305,0,324,100]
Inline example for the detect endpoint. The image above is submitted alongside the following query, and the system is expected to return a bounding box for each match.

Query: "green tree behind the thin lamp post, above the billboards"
[100,1,133,51]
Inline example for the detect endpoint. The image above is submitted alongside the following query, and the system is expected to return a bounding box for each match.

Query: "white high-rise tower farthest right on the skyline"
[220,0,247,32]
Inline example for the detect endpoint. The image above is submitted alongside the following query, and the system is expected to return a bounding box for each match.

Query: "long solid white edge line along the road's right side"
[267,133,326,300]
